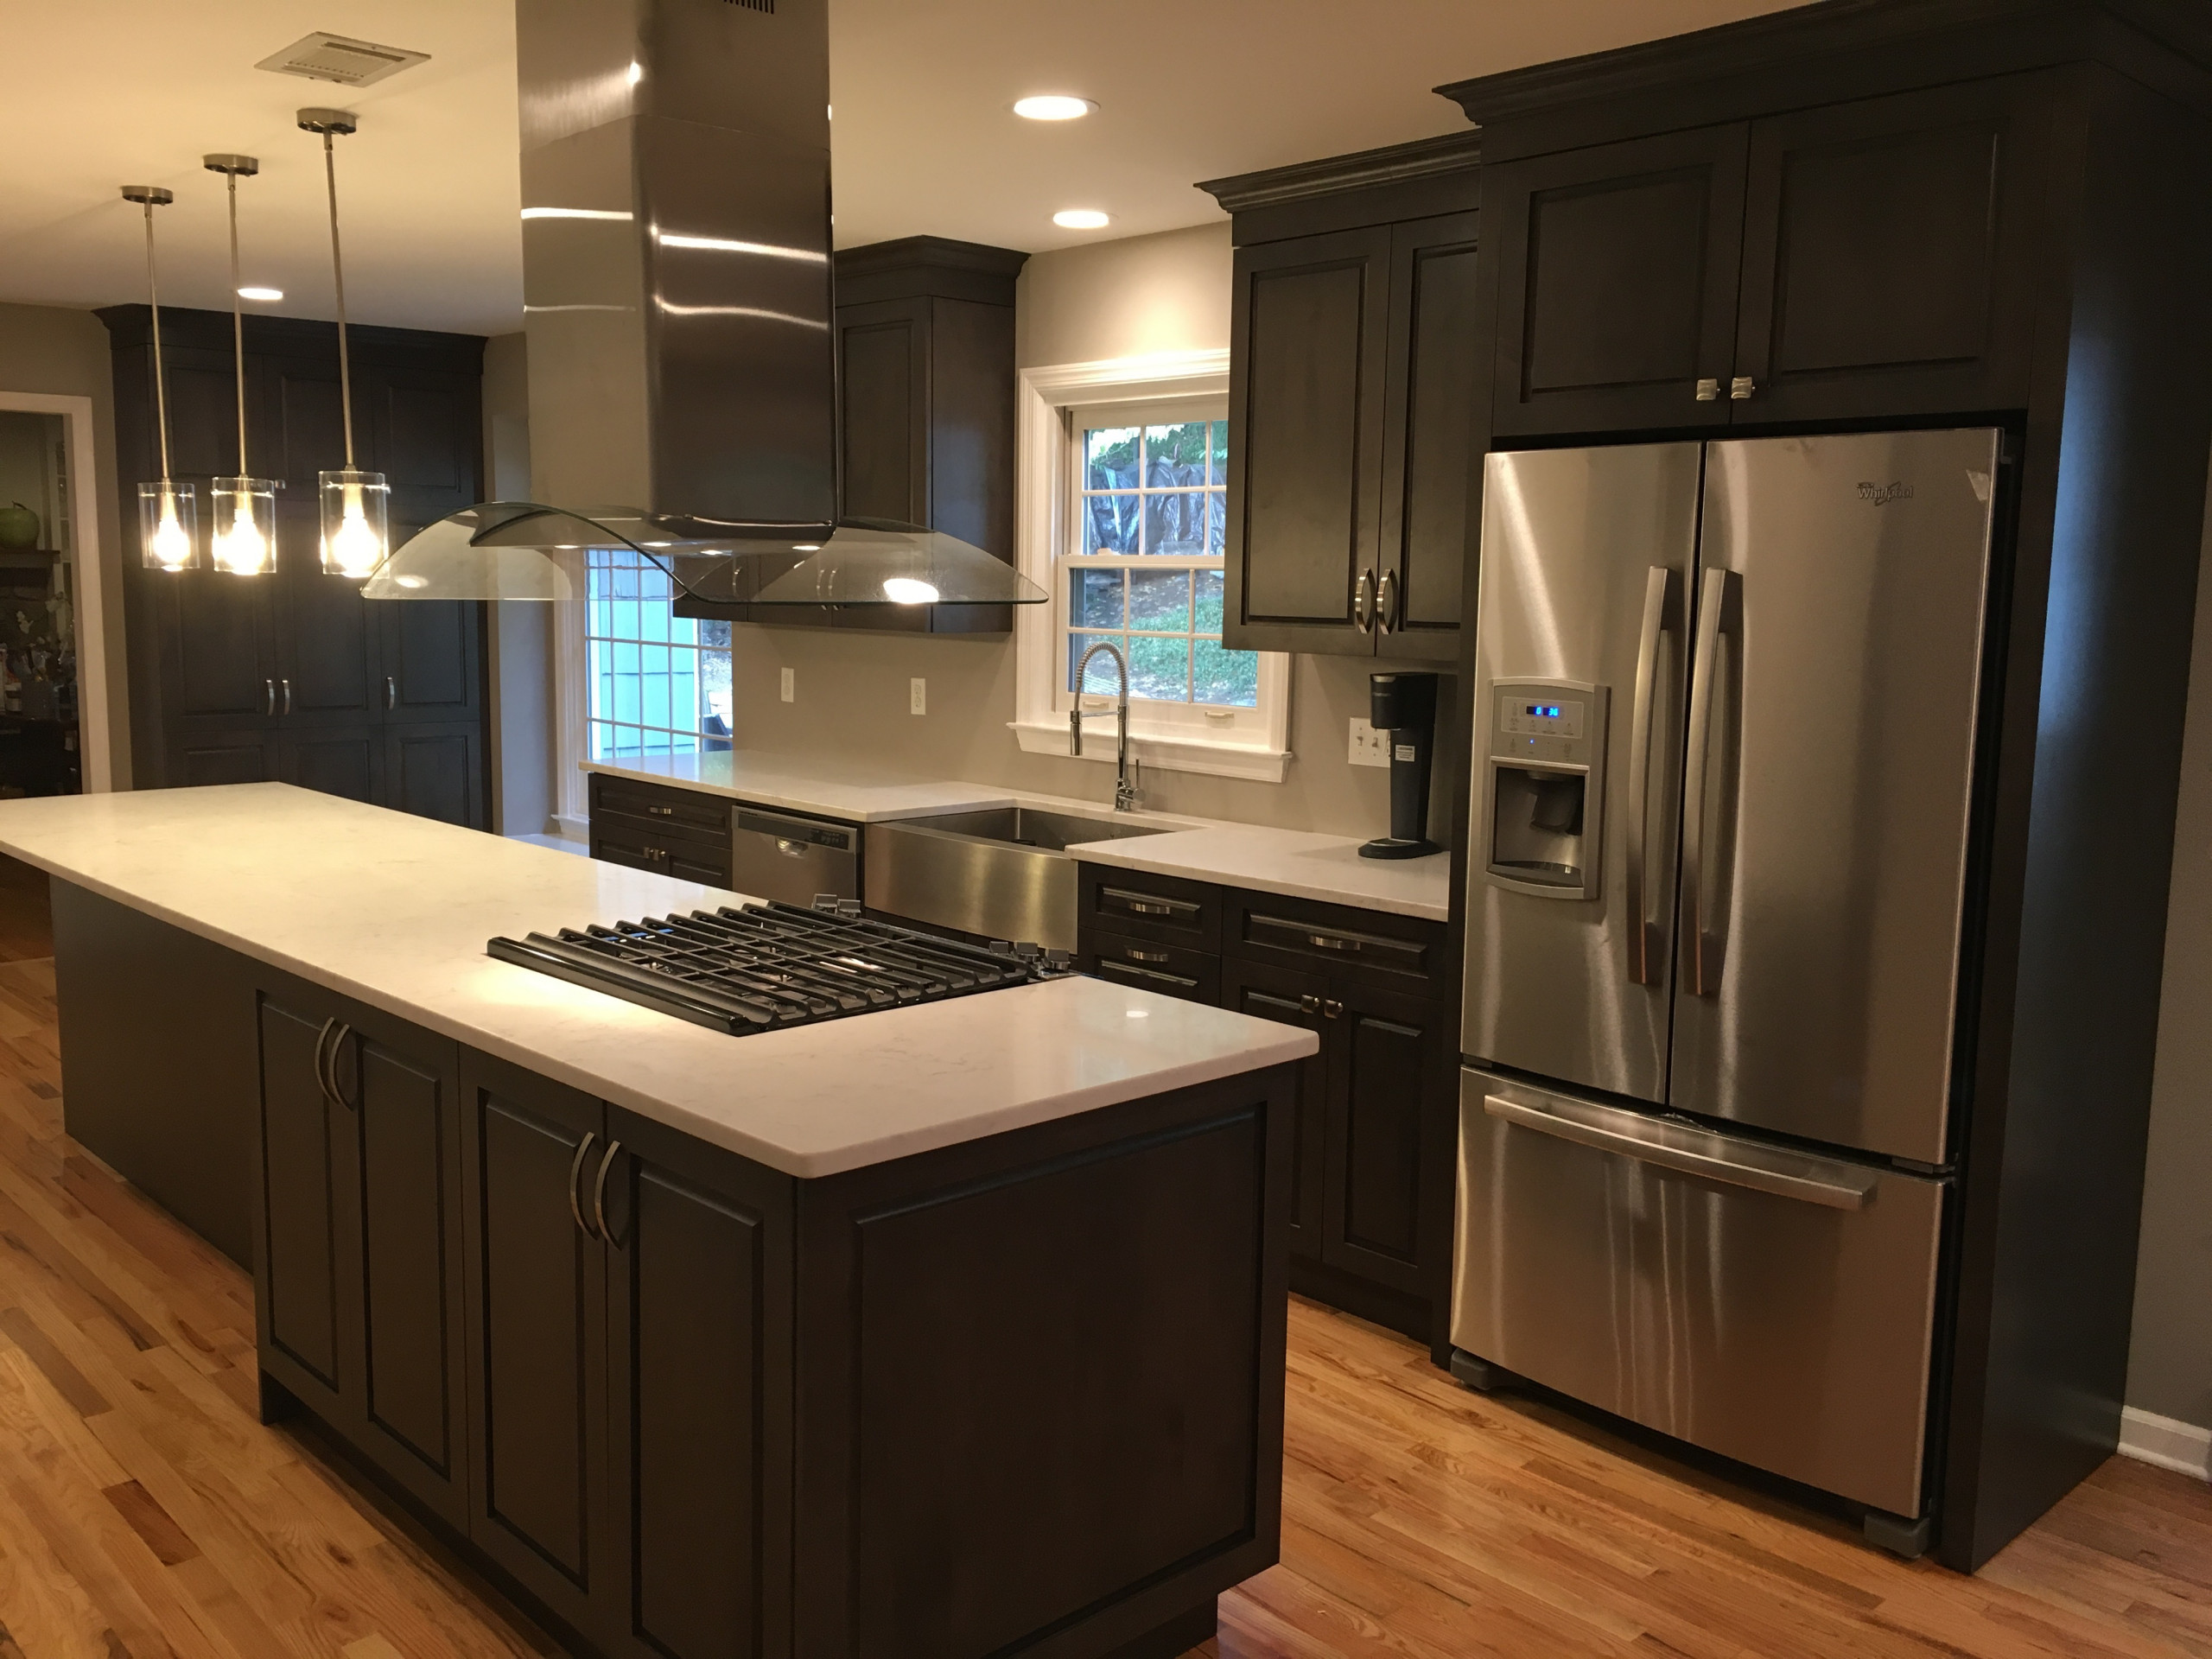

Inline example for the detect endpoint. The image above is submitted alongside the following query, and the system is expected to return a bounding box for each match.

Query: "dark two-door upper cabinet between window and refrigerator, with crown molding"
[1204,135,1482,661]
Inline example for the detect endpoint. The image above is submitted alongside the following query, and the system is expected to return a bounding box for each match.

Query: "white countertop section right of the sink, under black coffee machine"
[1068,823,1451,923]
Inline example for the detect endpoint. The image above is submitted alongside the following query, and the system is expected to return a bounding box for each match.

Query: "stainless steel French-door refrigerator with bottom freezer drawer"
[1451,429,1999,1517]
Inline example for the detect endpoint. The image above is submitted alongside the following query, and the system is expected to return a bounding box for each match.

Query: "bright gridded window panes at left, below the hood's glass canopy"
[584,546,730,761]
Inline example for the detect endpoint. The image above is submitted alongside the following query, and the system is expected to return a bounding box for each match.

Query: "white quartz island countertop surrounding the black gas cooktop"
[0,783,1316,1177]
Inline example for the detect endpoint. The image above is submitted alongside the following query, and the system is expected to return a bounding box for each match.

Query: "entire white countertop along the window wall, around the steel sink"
[584,750,1451,923]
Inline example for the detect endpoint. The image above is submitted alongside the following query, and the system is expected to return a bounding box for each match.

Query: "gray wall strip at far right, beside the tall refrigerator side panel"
[2128,473,2212,1427]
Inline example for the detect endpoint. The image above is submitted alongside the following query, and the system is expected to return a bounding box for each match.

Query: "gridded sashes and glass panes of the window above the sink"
[1059,420,1259,708]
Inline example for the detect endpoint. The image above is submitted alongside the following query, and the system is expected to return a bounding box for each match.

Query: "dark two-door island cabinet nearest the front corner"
[462,1053,791,1659]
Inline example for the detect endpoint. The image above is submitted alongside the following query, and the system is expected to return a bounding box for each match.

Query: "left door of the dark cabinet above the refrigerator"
[1482,124,1747,435]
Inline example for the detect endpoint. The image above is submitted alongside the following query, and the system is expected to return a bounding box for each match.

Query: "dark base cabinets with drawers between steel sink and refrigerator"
[1075,862,1458,1338]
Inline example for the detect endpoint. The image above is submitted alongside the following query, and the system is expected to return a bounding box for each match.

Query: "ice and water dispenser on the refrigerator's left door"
[1482,679,1606,898]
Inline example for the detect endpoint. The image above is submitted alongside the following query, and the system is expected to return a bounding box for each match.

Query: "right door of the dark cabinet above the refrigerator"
[1734,75,2049,425]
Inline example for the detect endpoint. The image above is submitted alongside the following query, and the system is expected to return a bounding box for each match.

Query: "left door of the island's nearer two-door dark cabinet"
[462,1051,617,1630]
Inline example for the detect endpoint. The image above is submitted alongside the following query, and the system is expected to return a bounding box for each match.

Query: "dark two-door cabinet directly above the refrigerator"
[1482,75,2046,435]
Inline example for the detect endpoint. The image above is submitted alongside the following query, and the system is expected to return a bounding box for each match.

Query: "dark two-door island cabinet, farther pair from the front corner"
[254,980,467,1524]
